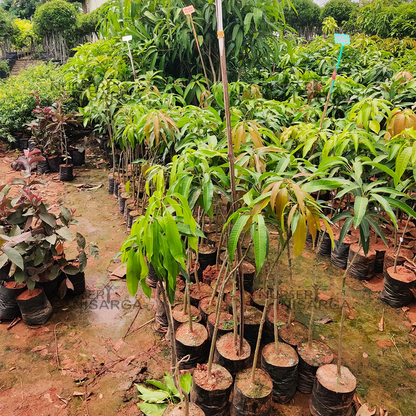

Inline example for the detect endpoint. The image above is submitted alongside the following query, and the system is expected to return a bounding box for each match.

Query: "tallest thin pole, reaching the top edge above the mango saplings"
[215,0,245,354]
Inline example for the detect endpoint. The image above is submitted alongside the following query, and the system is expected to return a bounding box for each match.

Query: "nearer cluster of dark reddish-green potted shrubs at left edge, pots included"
[0,179,98,325]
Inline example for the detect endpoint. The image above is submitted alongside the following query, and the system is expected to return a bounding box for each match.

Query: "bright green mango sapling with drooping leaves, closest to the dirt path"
[121,170,206,414]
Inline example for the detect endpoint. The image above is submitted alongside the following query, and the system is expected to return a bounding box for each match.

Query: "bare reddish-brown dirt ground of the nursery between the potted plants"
[0,148,416,416]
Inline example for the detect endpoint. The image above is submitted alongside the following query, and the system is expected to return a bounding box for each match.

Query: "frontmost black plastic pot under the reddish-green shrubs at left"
[17,288,52,325]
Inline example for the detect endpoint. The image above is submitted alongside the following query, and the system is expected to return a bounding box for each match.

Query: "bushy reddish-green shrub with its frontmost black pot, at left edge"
[0,179,97,324]
